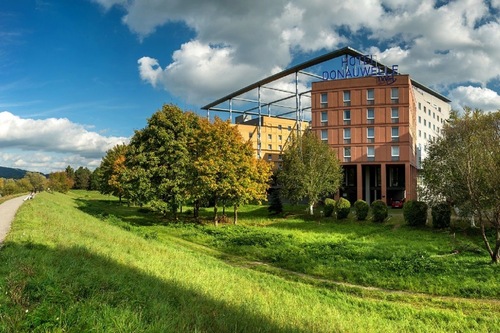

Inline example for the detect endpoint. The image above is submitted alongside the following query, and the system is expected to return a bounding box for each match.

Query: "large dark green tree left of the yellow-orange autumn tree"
[125,104,196,217]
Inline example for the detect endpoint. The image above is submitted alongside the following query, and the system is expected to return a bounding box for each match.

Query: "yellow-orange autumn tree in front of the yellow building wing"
[190,118,271,224]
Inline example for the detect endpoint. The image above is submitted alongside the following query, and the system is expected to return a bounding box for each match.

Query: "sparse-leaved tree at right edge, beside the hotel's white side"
[423,107,500,263]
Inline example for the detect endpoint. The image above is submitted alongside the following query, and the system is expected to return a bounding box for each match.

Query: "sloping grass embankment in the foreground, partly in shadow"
[0,193,500,332]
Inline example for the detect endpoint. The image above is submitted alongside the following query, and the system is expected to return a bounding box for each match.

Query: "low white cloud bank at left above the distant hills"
[0,111,128,172]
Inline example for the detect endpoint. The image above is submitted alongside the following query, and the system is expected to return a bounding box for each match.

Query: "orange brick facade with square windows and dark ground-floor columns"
[311,75,417,204]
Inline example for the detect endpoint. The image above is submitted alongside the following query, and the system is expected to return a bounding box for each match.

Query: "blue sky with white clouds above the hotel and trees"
[0,0,500,173]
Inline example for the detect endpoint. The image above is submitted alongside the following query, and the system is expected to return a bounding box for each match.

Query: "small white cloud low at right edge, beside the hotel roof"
[450,86,500,111]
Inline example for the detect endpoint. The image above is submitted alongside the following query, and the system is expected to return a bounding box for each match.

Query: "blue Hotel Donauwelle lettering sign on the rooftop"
[323,54,398,84]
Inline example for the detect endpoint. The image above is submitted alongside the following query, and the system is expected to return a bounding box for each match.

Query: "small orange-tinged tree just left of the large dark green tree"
[98,144,127,202]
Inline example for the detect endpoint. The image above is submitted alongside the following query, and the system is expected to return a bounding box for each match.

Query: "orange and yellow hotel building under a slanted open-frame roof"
[203,47,451,204]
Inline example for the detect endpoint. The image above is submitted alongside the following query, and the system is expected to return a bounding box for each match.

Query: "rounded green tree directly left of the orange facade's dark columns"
[278,131,342,215]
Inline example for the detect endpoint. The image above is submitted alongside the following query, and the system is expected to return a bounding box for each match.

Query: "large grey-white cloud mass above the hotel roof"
[94,0,500,104]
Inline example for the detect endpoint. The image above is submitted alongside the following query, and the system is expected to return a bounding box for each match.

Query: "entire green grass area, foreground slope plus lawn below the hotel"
[0,192,500,332]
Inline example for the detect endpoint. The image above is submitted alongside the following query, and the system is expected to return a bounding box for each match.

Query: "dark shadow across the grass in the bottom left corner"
[0,242,302,332]
